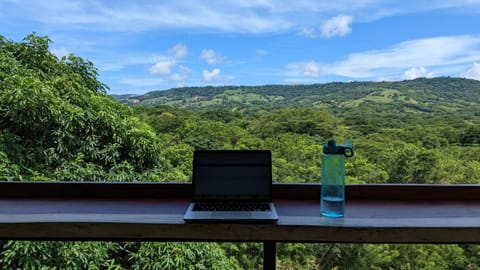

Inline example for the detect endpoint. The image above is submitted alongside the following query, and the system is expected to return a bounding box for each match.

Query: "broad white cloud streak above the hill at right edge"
[323,36,480,78]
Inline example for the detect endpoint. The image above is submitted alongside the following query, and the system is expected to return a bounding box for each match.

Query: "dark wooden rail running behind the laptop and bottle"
[0,182,480,200]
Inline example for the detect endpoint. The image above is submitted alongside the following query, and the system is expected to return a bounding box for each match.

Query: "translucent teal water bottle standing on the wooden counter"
[320,140,353,217]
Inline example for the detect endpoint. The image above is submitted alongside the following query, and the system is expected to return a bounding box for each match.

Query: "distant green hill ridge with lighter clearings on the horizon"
[115,77,480,116]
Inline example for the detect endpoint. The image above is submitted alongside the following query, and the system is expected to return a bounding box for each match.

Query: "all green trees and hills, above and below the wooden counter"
[0,34,480,269]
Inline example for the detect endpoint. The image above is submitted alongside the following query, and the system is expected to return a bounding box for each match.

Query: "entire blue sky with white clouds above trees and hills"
[0,0,480,94]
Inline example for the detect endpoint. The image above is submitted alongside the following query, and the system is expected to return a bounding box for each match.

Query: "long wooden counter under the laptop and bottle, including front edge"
[0,192,480,243]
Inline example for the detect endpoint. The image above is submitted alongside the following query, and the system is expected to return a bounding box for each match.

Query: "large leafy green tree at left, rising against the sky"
[0,34,163,180]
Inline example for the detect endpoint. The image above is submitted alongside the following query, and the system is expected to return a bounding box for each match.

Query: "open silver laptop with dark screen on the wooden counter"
[184,150,278,222]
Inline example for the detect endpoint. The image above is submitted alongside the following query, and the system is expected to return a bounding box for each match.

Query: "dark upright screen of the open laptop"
[192,150,272,201]
